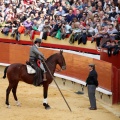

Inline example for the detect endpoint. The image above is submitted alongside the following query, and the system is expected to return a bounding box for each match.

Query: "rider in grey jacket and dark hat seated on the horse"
[29,38,47,86]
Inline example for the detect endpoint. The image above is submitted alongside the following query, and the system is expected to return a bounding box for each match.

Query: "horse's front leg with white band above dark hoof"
[43,82,50,110]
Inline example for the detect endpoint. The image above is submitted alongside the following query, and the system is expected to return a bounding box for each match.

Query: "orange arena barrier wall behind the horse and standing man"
[0,43,118,104]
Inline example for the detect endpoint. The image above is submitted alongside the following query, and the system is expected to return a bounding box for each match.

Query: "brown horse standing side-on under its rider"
[3,50,66,109]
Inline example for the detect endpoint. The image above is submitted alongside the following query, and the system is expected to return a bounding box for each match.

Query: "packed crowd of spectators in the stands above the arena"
[0,0,120,54]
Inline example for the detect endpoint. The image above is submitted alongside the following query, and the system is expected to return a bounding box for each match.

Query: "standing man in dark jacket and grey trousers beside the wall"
[86,63,98,110]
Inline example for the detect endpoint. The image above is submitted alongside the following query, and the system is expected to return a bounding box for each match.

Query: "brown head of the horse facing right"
[57,50,66,70]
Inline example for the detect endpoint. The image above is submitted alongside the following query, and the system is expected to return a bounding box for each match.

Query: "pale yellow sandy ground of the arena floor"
[0,73,120,120]
